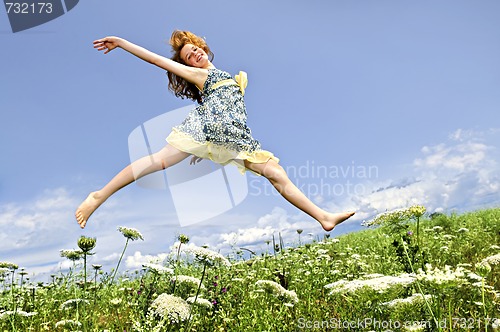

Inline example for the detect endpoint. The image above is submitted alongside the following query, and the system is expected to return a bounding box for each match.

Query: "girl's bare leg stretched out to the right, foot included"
[245,159,354,232]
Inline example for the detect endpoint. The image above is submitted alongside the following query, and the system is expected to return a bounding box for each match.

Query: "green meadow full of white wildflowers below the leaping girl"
[0,206,500,332]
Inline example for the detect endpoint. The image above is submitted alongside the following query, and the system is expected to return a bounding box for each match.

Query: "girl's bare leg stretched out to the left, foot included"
[75,144,189,228]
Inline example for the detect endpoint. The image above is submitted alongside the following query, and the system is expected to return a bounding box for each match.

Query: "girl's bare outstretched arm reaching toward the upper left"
[94,37,208,87]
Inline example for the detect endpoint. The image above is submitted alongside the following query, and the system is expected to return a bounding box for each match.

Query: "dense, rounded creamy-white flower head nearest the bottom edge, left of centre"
[150,293,191,323]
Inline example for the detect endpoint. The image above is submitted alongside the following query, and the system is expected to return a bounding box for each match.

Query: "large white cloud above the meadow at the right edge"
[328,130,500,219]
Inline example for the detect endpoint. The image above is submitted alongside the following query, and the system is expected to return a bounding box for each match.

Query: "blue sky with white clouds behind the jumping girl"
[0,0,500,278]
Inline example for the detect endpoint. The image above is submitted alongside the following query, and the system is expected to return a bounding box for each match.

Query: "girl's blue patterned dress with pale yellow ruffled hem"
[167,69,279,172]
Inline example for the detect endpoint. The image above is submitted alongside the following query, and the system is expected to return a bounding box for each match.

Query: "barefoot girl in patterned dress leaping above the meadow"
[75,31,354,231]
